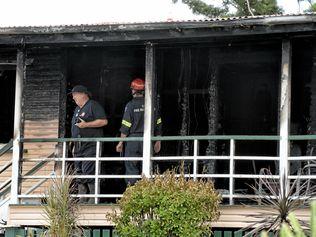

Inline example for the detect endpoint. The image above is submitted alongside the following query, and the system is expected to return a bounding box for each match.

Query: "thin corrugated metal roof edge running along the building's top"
[0,13,316,29]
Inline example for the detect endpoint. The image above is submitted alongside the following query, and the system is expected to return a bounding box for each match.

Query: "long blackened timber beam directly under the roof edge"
[0,20,316,45]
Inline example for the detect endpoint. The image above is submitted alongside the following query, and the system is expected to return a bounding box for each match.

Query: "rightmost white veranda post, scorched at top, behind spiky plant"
[279,40,292,193]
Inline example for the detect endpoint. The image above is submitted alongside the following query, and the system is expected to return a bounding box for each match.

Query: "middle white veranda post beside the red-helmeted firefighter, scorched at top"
[143,43,155,177]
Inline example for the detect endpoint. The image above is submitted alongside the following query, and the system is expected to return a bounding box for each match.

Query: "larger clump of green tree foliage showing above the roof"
[172,0,283,18]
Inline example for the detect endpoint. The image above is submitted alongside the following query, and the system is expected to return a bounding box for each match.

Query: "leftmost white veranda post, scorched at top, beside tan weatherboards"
[10,50,24,204]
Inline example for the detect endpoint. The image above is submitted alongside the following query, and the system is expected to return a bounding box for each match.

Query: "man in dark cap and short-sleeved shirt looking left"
[70,85,108,202]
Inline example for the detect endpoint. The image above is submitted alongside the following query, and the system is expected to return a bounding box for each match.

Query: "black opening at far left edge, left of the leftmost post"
[0,68,16,143]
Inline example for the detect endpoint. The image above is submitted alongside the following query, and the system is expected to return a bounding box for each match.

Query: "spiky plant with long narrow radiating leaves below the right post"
[243,169,315,237]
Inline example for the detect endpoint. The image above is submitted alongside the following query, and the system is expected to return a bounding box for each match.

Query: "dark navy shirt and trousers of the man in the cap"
[71,100,106,182]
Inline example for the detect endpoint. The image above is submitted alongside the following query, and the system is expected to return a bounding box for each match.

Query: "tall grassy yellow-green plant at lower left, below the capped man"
[43,172,82,237]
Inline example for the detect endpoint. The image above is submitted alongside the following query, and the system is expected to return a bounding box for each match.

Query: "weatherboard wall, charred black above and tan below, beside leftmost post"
[20,48,66,194]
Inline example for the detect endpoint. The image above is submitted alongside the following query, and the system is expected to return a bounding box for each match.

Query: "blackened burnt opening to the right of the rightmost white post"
[289,38,316,174]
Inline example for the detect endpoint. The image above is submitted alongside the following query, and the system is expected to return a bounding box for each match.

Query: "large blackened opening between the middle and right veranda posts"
[156,42,281,191]
